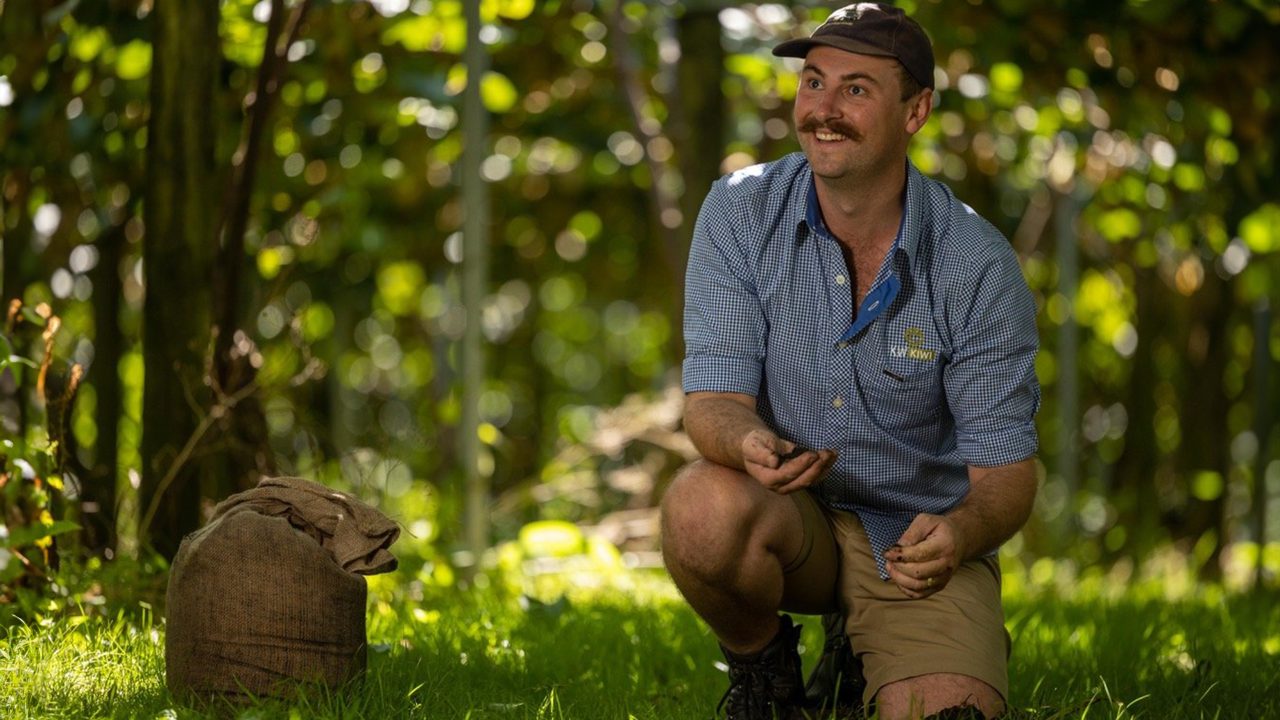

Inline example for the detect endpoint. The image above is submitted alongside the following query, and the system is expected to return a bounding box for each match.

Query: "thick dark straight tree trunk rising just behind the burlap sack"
[138,0,220,559]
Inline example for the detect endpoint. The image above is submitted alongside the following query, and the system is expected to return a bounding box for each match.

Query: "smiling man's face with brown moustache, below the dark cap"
[795,46,923,181]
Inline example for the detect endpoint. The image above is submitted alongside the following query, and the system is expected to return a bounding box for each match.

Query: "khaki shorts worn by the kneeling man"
[782,491,1010,703]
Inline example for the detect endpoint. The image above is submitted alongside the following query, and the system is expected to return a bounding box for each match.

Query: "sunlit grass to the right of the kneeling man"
[1005,548,1280,719]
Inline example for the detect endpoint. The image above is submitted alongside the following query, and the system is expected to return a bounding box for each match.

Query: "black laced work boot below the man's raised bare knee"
[717,615,805,720]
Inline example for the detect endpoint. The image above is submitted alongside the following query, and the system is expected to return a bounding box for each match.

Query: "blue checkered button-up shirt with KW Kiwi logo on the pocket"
[684,154,1039,577]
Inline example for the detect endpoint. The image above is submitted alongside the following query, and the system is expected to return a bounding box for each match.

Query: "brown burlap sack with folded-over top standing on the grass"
[165,478,397,700]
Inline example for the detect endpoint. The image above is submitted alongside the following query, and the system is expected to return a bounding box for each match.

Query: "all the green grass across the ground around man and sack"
[0,563,1280,720]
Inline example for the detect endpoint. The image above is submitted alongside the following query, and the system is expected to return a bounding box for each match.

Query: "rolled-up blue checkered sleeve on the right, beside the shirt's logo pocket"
[943,240,1041,468]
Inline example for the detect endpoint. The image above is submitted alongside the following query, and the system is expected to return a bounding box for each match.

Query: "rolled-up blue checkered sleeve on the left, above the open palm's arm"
[682,181,768,396]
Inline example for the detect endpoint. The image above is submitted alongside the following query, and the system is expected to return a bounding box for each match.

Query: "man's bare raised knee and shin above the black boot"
[662,460,804,653]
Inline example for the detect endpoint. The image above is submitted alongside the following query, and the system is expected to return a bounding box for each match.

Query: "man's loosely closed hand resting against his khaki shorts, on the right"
[884,512,965,600]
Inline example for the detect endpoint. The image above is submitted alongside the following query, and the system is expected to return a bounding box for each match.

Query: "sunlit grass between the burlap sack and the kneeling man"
[370,573,723,719]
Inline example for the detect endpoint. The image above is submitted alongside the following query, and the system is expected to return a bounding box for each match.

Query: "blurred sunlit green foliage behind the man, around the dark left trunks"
[0,0,1280,599]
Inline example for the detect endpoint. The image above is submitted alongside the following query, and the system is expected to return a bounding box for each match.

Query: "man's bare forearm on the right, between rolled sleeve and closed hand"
[947,459,1037,560]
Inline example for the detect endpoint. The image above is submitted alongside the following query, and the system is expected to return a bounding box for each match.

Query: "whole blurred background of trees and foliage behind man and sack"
[0,0,1280,597]
